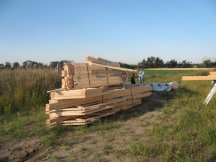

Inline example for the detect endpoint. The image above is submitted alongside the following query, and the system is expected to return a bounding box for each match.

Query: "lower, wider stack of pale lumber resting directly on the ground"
[46,85,152,127]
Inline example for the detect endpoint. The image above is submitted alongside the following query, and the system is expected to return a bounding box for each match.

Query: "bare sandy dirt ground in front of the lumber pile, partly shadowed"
[0,95,163,162]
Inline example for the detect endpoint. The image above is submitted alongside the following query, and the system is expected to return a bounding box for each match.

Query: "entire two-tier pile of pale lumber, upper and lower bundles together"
[46,57,152,127]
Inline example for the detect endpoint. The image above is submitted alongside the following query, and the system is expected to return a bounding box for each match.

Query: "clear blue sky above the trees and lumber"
[0,0,216,63]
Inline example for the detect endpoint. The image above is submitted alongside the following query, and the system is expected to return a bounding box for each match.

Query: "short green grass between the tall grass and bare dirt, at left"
[0,107,65,145]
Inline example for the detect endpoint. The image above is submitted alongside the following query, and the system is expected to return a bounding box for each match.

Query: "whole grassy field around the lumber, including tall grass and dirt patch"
[0,70,216,162]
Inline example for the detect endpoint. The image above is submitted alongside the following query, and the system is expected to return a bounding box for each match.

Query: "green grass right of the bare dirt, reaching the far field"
[126,71,216,161]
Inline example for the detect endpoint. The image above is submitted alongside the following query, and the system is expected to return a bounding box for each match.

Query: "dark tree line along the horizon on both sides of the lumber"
[0,56,216,69]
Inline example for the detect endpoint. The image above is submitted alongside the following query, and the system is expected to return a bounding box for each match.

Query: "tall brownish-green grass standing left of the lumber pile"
[0,69,60,114]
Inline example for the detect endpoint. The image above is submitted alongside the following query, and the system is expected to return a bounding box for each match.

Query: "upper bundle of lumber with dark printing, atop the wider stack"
[61,56,136,90]
